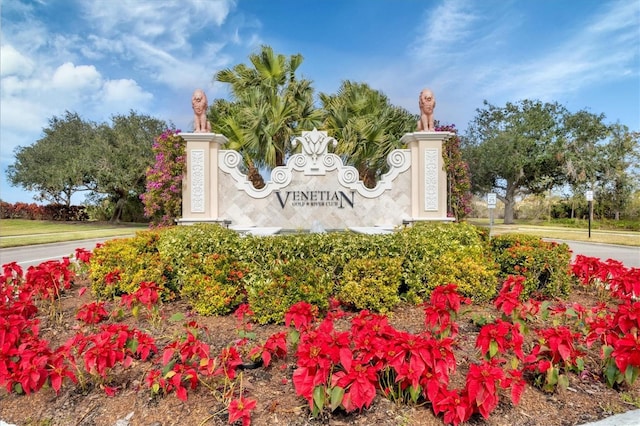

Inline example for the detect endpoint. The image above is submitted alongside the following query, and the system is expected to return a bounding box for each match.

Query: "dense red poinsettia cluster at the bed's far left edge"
[0,259,156,395]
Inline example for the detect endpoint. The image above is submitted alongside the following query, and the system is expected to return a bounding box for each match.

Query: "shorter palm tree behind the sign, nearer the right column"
[320,80,416,188]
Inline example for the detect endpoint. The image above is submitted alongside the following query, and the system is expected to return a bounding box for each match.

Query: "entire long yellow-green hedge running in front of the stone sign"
[90,223,570,323]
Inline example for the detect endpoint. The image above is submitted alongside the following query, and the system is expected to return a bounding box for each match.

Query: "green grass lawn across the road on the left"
[0,219,149,248]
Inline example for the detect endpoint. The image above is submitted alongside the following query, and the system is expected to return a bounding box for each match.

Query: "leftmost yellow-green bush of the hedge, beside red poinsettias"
[89,231,170,299]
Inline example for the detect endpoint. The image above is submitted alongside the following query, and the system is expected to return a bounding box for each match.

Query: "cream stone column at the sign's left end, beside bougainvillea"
[178,133,227,224]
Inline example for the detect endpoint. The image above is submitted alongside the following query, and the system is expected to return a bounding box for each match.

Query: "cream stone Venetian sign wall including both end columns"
[178,129,453,233]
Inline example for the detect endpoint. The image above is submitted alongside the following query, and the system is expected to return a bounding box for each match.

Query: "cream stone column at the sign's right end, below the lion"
[401,132,455,221]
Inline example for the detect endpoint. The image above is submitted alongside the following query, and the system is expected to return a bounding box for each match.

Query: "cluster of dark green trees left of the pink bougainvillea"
[7,111,167,221]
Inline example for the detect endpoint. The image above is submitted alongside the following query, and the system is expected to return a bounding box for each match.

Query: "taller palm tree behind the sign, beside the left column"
[209,46,321,176]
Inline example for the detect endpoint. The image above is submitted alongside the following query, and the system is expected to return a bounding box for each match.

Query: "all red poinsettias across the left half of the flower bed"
[0,251,268,425]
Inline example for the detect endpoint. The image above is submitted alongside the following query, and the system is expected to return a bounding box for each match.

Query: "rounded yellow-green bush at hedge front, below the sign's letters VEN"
[245,259,333,324]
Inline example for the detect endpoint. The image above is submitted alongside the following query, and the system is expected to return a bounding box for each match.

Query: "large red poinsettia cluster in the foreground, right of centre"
[286,285,524,424]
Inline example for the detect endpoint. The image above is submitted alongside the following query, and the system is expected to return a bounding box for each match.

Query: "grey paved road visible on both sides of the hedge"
[0,238,640,269]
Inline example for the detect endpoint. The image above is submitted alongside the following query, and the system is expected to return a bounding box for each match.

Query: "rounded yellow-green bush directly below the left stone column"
[180,254,246,315]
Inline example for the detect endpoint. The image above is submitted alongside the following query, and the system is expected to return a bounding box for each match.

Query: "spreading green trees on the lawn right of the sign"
[462,100,640,223]
